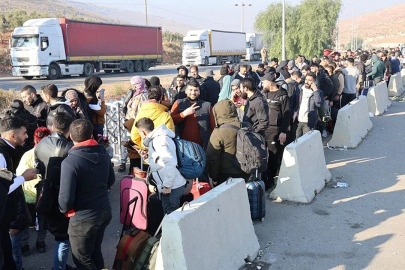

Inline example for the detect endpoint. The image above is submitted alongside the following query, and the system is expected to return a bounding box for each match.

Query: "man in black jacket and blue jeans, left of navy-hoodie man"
[35,113,73,270]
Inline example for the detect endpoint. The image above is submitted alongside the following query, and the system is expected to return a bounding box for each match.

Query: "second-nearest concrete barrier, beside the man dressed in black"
[270,130,331,203]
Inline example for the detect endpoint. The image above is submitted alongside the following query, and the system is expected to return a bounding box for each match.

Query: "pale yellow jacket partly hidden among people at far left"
[16,148,41,204]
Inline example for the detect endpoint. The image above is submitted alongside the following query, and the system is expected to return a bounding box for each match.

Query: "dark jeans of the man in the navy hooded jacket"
[68,211,111,270]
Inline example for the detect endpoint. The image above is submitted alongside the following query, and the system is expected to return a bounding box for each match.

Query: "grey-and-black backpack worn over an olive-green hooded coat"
[220,124,269,173]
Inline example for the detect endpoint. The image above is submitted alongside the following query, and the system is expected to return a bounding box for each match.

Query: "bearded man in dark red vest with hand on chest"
[171,79,215,150]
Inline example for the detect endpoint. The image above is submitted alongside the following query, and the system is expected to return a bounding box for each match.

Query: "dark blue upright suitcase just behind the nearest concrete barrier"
[246,173,266,221]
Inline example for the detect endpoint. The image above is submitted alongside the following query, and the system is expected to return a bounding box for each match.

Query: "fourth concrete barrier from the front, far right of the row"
[367,82,392,116]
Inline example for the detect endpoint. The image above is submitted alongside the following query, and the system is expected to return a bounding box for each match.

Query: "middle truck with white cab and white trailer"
[182,29,246,66]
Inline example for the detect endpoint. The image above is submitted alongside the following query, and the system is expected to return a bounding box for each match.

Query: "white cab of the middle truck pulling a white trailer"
[182,30,211,66]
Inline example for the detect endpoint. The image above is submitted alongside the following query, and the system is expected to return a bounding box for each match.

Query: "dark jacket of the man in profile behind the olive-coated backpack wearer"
[243,91,269,136]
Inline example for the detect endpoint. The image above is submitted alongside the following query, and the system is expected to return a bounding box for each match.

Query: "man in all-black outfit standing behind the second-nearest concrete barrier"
[262,73,291,189]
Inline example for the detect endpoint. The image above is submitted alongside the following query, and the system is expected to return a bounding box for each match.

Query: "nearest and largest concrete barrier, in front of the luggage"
[155,179,260,270]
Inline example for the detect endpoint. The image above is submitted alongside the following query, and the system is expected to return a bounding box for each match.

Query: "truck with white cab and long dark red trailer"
[10,18,163,80]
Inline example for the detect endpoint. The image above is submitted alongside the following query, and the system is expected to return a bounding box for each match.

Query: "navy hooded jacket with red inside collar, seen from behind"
[59,139,115,222]
